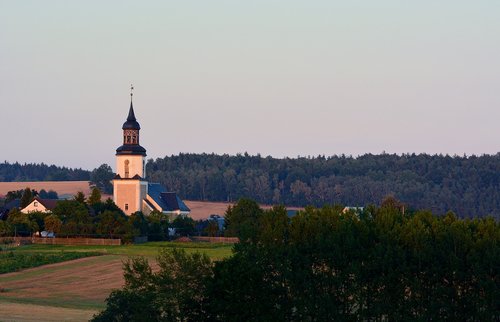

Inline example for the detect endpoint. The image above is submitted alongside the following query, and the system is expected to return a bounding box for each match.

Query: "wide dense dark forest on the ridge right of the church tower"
[147,154,500,218]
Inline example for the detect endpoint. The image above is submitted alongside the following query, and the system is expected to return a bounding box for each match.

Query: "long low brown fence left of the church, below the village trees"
[0,237,122,246]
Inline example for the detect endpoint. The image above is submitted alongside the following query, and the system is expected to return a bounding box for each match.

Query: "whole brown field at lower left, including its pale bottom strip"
[0,255,126,321]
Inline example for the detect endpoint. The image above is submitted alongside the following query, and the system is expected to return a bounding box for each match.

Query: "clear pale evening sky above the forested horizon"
[0,0,500,170]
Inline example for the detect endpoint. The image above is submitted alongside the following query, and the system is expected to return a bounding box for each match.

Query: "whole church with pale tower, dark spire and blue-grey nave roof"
[113,93,190,216]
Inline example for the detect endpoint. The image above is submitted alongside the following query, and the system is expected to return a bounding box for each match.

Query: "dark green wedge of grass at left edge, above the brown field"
[0,250,100,274]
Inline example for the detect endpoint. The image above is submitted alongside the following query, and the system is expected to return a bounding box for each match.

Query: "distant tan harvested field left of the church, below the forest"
[0,181,90,196]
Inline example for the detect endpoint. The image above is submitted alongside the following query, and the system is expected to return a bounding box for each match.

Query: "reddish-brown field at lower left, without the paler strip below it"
[0,255,124,309]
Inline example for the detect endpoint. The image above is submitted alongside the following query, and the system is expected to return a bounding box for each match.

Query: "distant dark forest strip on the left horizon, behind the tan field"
[0,161,90,182]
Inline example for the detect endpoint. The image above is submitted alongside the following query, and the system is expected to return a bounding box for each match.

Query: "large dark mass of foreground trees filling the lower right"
[93,198,500,322]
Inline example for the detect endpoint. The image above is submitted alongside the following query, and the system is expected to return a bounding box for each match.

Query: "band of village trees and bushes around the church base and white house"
[0,188,211,243]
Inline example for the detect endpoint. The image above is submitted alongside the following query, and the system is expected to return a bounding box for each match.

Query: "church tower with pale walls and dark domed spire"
[113,87,148,215]
